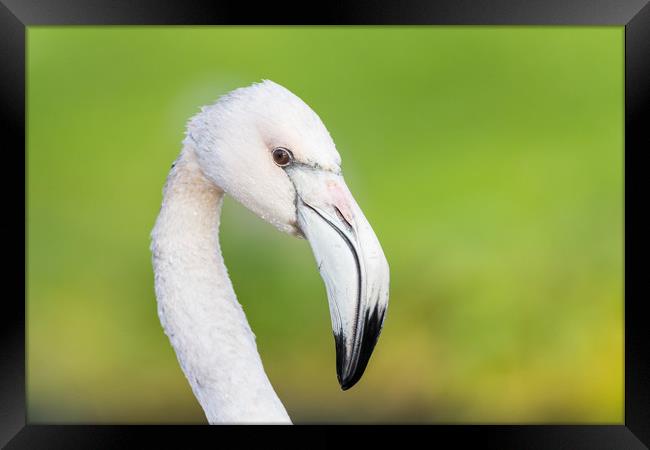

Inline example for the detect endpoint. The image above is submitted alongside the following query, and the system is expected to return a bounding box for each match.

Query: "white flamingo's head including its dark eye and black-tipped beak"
[186,80,389,390]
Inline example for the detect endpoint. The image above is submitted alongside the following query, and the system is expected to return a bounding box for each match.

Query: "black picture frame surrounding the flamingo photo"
[0,0,650,449]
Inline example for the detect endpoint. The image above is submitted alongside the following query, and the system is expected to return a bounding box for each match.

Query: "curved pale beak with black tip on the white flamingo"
[287,167,389,390]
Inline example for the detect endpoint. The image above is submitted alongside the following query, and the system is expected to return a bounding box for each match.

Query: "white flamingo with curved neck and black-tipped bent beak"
[151,80,389,424]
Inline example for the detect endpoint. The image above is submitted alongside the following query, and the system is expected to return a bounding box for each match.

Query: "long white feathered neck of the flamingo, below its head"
[151,146,291,424]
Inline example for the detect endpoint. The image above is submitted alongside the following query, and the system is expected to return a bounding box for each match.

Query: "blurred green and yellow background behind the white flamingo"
[27,27,624,423]
